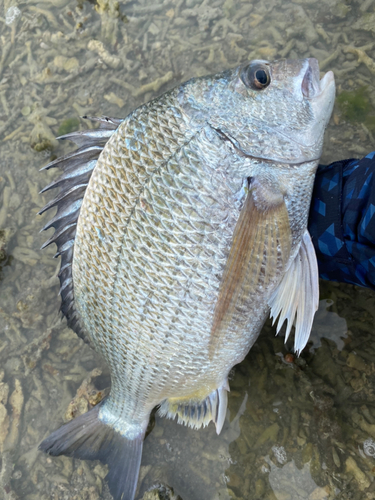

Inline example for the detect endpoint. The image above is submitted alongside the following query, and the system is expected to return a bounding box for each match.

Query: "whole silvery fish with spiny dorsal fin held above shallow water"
[39,58,335,500]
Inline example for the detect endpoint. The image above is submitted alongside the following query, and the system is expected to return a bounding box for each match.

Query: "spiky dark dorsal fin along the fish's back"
[39,116,122,341]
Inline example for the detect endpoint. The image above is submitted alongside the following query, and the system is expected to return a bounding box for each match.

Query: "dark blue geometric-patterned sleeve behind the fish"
[309,151,375,290]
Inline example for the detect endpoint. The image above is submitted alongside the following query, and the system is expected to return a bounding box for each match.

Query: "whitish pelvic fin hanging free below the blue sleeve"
[269,230,319,354]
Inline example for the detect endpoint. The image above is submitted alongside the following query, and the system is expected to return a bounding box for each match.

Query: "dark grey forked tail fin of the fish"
[39,405,144,500]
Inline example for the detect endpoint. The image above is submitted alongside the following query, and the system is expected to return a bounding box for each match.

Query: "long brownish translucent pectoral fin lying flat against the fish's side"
[210,179,291,355]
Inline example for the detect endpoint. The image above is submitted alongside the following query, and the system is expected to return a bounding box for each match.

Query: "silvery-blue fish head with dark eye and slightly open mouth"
[181,58,335,164]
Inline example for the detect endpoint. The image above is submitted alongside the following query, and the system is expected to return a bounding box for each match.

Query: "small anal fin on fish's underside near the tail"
[158,381,229,434]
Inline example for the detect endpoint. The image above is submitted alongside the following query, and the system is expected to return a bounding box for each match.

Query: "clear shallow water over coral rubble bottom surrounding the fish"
[0,0,375,500]
